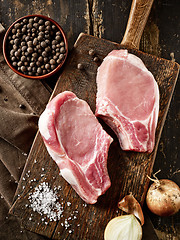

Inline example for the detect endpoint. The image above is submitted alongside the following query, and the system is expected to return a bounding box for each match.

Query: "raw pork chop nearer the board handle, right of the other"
[96,50,159,152]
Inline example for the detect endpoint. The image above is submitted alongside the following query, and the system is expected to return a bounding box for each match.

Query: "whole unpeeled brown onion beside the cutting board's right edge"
[146,179,180,217]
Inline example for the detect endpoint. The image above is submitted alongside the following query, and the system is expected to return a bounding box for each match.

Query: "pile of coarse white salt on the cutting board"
[28,182,64,221]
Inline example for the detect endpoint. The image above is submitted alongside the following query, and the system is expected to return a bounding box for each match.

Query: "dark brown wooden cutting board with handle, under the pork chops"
[10,0,179,240]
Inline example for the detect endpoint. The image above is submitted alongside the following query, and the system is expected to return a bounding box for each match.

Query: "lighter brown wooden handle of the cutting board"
[121,0,153,49]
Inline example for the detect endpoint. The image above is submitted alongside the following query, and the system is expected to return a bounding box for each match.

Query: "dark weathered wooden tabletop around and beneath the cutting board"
[0,0,180,240]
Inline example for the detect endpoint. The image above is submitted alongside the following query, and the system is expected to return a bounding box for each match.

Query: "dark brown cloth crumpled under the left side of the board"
[0,24,50,240]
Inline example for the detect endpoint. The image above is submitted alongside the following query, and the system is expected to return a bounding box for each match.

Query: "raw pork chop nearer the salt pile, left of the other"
[39,91,112,204]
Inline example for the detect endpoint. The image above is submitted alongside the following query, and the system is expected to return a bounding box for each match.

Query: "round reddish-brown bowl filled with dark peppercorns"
[3,15,68,79]
